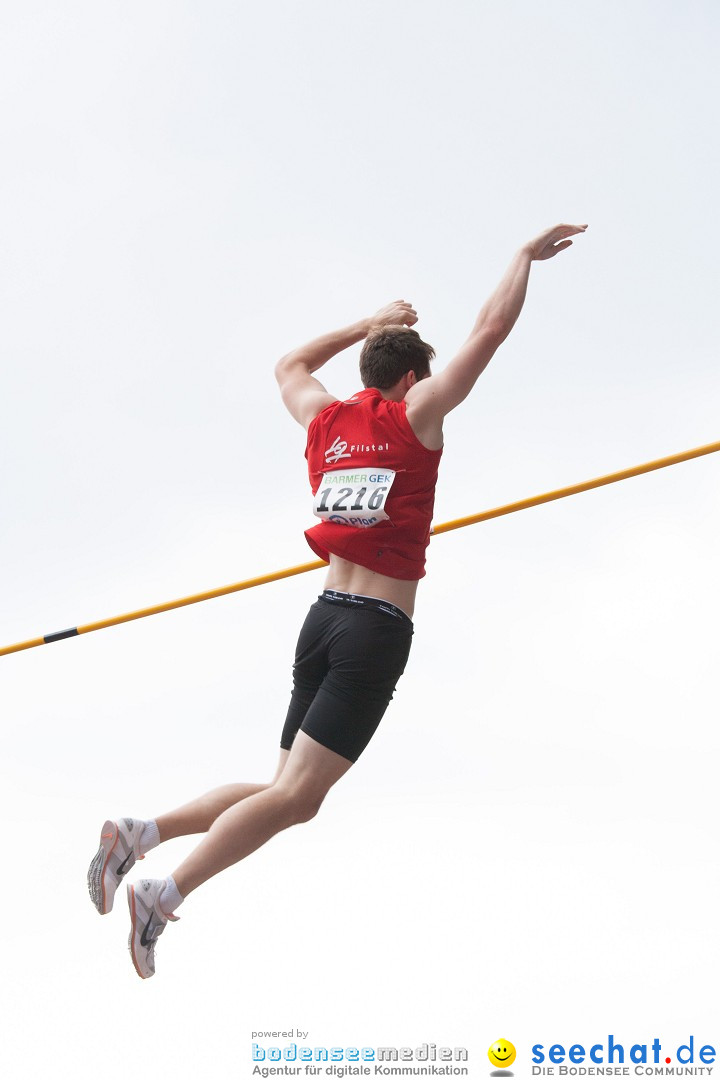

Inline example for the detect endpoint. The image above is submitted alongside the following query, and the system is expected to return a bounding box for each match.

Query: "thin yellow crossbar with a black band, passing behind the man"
[0,443,720,657]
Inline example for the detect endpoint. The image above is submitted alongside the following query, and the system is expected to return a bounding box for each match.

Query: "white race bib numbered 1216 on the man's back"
[313,469,395,529]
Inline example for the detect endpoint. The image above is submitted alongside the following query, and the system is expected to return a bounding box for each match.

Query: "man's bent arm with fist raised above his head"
[275,300,418,428]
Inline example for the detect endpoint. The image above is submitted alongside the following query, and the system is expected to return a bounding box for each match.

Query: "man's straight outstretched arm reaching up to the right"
[405,225,587,446]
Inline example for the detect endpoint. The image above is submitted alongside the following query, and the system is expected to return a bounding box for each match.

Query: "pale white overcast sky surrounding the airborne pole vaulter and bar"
[0,0,720,1080]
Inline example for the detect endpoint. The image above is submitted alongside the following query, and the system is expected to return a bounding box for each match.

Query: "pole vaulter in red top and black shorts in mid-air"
[87,225,587,978]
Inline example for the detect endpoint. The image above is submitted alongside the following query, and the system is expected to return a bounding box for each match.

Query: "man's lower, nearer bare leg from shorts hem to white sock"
[173,731,353,896]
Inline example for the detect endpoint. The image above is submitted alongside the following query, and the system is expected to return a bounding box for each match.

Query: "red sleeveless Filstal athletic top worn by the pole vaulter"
[305,389,443,581]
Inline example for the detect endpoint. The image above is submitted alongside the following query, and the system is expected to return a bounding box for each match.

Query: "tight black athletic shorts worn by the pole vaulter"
[280,590,412,761]
